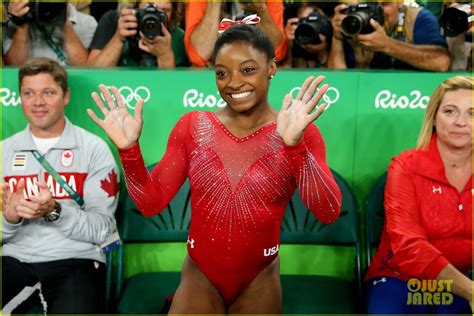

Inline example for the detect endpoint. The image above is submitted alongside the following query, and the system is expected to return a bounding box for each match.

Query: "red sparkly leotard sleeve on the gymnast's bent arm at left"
[119,114,191,216]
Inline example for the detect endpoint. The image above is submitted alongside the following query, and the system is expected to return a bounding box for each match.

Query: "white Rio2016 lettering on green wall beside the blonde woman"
[375,90,430,109]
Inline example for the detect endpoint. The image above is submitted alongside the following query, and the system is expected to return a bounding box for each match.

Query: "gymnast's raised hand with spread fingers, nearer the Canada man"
[87,84,144,149]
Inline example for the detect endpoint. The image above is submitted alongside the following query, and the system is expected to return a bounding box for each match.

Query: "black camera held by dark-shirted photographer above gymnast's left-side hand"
[136,4,167,40]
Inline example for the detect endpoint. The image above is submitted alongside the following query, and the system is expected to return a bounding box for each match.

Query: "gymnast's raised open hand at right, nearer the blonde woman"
[276,76,329,146]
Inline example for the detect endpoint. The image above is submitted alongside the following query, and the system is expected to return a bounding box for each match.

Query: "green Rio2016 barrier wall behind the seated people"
[1,68,470,276]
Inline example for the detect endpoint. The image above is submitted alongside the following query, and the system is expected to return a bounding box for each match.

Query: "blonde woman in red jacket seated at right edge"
[366,76,473,314]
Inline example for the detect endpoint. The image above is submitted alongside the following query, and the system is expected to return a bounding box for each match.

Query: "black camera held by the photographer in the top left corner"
[9,0,67,27]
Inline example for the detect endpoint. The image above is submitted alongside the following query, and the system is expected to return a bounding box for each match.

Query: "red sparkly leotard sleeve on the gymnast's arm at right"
[285,124,342,224]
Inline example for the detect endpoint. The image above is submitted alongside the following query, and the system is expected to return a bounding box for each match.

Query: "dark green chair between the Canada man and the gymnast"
[115,175,191,314]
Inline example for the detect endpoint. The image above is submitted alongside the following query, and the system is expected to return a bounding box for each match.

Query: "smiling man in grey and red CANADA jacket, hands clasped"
[1,57,119,315]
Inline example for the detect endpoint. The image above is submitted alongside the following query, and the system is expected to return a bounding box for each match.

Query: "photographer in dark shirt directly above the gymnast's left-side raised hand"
[87,1,188,68]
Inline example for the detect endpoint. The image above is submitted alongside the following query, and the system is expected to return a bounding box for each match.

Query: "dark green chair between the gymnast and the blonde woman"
[281,170,362,314]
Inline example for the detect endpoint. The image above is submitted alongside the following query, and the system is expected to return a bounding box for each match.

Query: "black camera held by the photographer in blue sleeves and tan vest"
[341,2,384,37]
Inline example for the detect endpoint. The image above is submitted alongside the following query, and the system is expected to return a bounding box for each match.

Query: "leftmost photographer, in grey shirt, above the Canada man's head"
[3,1,97,66]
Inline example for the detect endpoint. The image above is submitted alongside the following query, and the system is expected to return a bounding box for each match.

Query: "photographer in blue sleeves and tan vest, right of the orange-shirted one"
[328,1,450,71]
